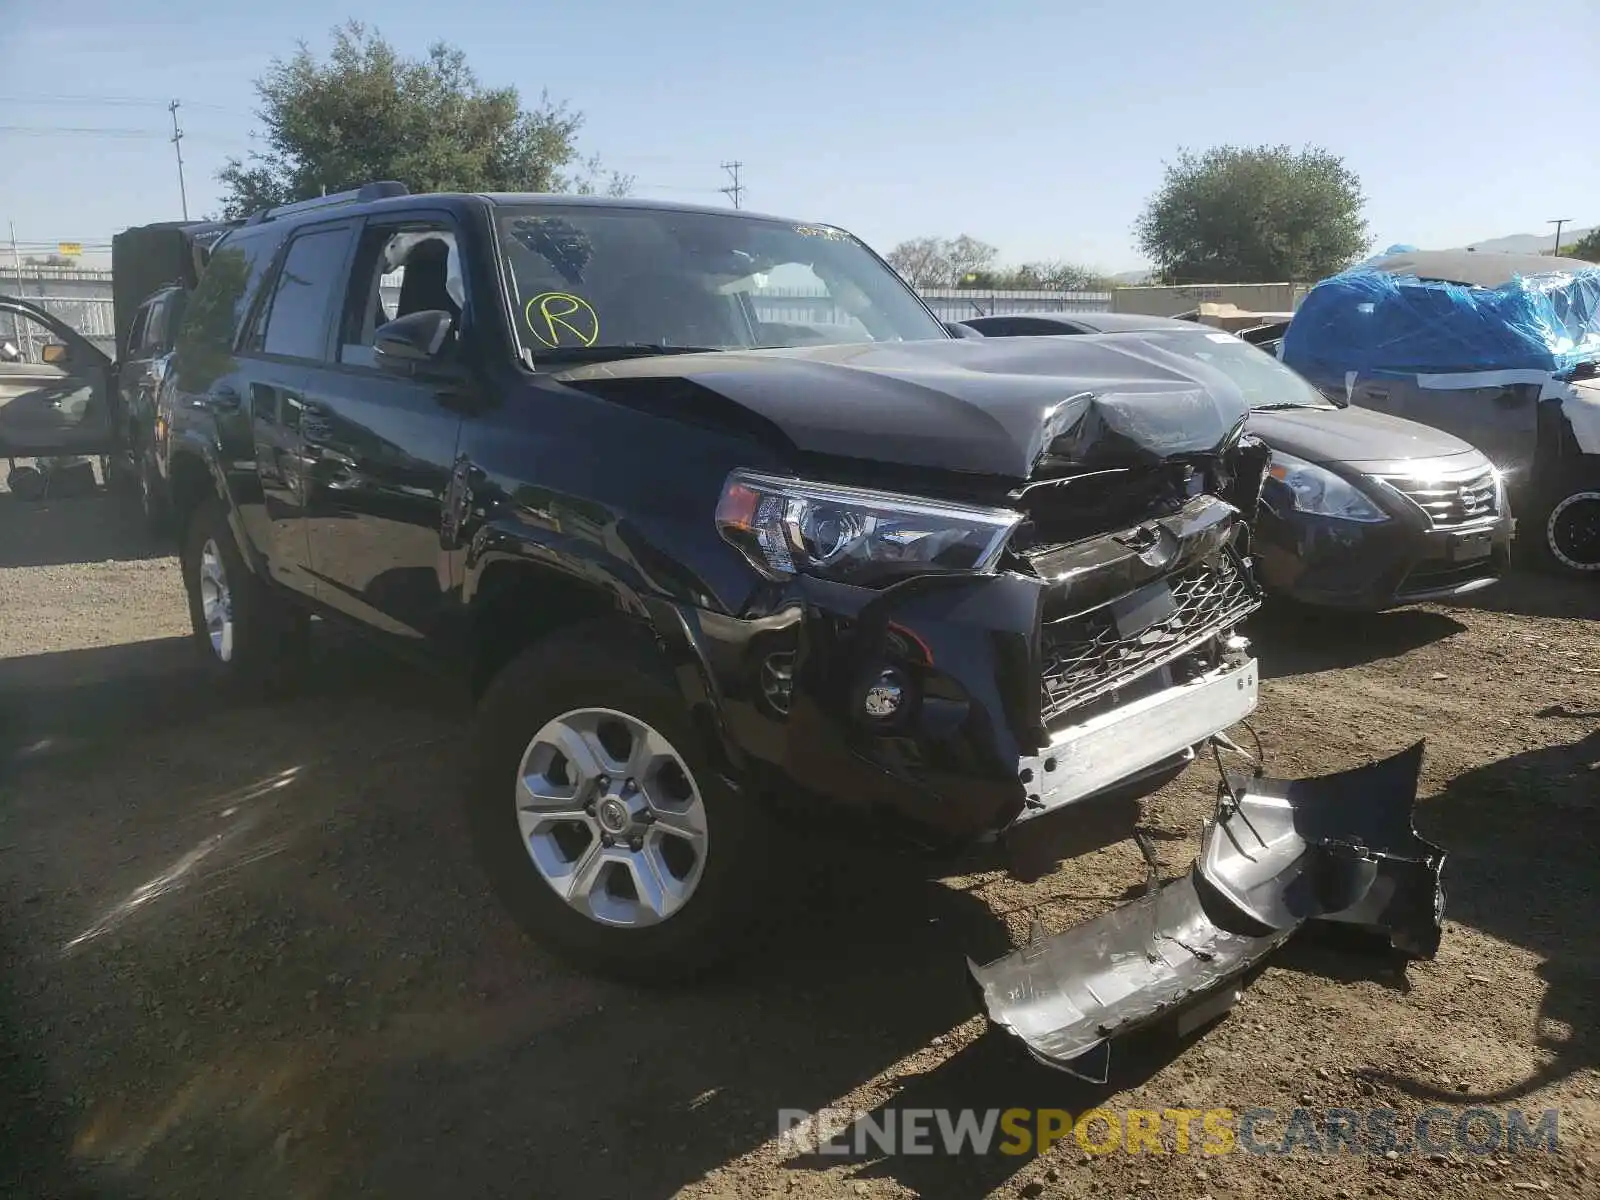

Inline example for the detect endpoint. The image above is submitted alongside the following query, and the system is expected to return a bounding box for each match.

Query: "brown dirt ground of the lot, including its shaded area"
[0,494,1600,1200]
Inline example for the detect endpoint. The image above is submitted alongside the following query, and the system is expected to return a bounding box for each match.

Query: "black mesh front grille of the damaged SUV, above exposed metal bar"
[1042,550,1261,723]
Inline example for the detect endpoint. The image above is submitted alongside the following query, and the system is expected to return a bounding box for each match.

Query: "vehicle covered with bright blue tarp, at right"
[1282,248,1600,579]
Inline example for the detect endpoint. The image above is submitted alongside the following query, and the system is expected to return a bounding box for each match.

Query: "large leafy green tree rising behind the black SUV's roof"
[218,21,632,218]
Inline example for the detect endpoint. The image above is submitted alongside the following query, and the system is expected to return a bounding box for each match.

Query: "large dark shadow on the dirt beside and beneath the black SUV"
[0,637,1440,1200]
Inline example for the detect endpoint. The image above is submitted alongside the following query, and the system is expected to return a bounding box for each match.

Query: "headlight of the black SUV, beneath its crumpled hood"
[717,470,1022,586]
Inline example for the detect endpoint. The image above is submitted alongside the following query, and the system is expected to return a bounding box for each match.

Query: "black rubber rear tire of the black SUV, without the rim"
[179,498,310,694]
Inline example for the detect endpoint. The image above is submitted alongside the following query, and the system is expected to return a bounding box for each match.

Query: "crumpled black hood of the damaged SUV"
[555,336,1250,482]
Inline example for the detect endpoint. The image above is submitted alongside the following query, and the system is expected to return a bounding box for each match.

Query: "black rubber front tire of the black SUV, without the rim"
[467,619,773,984]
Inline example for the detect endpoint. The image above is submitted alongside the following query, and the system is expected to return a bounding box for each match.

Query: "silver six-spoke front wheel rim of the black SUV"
[517,709,709,928]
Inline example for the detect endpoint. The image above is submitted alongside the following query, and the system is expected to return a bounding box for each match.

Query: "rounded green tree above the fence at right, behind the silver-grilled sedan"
[1134,146,1371,283]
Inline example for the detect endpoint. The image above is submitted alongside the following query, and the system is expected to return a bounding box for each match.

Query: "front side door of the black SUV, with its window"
[304,214,466,643]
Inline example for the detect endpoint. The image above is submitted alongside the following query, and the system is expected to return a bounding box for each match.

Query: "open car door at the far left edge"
[0,296,117,458]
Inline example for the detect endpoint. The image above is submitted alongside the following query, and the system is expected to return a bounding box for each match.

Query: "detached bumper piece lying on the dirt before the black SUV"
[968,742,1445,1082]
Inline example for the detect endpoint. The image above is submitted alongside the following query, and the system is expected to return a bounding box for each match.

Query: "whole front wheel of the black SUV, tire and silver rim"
[469,622,771,982]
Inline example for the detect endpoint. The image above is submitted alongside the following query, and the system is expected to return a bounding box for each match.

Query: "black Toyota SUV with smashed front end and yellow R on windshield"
[140,184,1452,1068]
